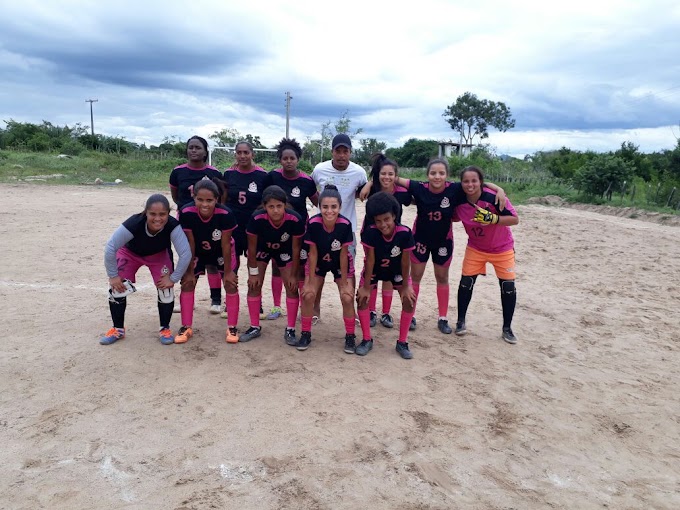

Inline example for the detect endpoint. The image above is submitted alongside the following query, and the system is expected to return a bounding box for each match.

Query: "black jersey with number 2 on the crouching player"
[361,223,416,281]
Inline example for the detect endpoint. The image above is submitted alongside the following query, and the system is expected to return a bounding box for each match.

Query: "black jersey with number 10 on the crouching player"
[246,208,305,262]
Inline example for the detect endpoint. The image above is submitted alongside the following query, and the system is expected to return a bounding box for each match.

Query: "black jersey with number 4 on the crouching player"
[305,214,354,274]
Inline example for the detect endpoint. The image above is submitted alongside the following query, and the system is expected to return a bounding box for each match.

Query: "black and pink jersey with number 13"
[409,180,467,241]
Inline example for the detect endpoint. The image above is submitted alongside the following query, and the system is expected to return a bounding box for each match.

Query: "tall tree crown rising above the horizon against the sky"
[442,92,515,144]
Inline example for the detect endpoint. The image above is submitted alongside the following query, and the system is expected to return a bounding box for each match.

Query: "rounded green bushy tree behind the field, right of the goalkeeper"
[574,154,635,196]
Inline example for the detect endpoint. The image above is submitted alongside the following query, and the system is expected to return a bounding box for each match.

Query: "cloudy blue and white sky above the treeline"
[0,0,680,156]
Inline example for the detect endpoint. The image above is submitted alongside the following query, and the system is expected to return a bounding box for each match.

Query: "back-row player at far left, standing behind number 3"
[170,136,222,314]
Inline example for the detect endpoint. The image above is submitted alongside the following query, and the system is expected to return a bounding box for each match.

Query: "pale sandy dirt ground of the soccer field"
[0,185,680,509]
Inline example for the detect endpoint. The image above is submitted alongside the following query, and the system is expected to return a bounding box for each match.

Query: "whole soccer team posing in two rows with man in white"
[99,135,519,359]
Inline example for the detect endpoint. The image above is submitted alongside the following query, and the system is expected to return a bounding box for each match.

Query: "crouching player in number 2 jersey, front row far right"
[356,191,416,359]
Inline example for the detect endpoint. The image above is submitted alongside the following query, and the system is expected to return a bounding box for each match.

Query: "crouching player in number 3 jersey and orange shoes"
[175,179,239,344]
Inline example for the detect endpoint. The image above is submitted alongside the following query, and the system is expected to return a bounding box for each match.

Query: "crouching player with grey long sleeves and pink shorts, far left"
[99,194,191,345]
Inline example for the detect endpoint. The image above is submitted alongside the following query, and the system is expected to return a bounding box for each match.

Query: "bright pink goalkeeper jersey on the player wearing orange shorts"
[456,188,517,253]
